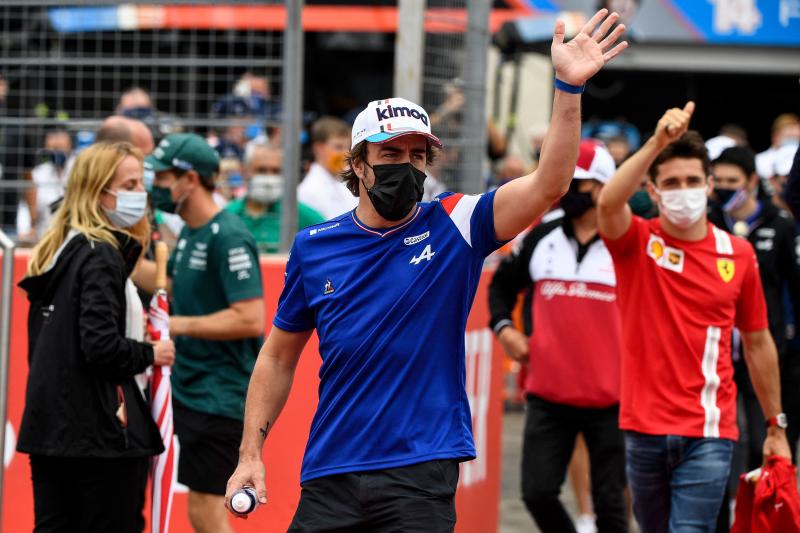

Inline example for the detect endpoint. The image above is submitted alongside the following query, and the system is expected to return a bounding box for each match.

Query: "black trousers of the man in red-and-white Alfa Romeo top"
[522,395,628,533]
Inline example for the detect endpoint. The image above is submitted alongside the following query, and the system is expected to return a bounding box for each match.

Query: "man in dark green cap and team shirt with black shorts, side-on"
[133,133,264,533]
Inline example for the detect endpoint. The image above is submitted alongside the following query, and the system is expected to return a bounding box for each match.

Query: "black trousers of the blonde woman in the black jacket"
[30,455,149,533]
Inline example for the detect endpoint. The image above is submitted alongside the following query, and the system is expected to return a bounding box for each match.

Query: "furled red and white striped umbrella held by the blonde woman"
[148,289,176,533]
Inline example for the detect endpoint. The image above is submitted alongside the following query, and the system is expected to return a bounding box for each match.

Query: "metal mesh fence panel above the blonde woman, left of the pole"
[0,0,284,241]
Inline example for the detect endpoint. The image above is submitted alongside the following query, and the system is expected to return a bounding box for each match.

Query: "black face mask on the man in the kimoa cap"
[365,162,425,222]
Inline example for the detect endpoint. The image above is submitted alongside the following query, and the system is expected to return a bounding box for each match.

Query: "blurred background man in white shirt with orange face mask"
[297,117,358,219]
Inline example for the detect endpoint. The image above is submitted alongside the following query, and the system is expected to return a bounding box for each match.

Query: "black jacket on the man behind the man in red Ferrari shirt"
[708,198,800,353]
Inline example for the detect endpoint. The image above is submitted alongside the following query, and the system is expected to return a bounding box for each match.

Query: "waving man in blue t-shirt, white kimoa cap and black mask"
[226,10,626,532]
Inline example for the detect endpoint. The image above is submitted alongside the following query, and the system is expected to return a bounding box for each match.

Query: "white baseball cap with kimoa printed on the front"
[350,98,442,149]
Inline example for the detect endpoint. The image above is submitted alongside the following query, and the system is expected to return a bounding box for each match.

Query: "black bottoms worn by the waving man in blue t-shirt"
[289,459,458,533]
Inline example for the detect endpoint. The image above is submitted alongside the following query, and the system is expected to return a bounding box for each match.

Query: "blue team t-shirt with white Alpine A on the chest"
[273,192,502,482]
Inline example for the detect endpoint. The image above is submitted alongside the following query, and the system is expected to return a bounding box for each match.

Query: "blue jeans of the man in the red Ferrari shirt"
[625,431,734,533]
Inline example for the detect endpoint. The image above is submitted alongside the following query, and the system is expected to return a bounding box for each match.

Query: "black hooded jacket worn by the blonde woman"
[17,230,163,458]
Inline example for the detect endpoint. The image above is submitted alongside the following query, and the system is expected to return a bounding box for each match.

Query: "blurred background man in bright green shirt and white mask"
[225,144,325,253]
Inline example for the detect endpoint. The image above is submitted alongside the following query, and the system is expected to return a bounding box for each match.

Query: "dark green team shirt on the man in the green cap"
[167,211,263,420]
